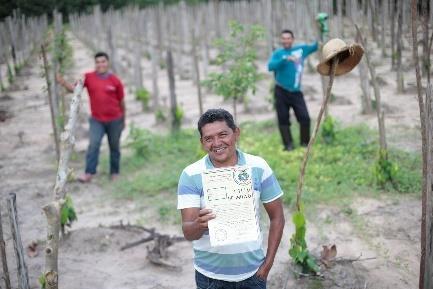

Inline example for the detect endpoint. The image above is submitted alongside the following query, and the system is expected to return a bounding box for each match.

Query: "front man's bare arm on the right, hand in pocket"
[256,198,285,280]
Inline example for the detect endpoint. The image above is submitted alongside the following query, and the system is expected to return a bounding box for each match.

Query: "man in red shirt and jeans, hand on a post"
[57,52,125,182]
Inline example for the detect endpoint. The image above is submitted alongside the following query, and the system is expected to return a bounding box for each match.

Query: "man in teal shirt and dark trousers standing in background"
[268,30,318,151]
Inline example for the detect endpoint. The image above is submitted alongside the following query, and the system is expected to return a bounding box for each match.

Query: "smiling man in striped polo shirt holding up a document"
[177,109,284,289]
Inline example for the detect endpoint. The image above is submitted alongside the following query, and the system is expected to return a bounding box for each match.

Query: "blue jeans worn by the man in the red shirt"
[86,117,123,175]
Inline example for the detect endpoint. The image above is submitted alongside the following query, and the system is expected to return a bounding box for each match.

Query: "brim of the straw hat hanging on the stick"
[317,44,364,76]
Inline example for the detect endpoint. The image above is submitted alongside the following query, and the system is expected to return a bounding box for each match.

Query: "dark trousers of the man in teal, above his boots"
[275,85,310,126]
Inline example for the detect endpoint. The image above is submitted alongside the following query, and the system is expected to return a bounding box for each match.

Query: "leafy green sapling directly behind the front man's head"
[202,21,264,119]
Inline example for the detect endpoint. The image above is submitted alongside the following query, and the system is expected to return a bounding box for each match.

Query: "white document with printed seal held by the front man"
[202,166,260,247]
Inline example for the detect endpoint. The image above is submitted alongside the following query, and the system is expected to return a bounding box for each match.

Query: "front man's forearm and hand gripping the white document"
[181,208,215,241]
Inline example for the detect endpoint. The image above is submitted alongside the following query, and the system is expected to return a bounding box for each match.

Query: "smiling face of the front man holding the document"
[200,121,240,167]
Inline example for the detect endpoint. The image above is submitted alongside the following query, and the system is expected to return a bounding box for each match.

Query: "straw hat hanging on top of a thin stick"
[317,38,364,76]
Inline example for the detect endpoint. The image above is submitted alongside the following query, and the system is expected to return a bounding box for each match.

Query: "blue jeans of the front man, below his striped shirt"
[195,271,266,289]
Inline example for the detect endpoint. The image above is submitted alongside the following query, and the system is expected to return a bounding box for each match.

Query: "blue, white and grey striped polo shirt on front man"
[177,150,283,282]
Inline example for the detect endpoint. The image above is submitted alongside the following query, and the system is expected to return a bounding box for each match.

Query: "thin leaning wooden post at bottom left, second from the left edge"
[8,193,30,289]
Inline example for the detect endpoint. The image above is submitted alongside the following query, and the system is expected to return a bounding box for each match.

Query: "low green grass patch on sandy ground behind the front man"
[106,121,421,209]
